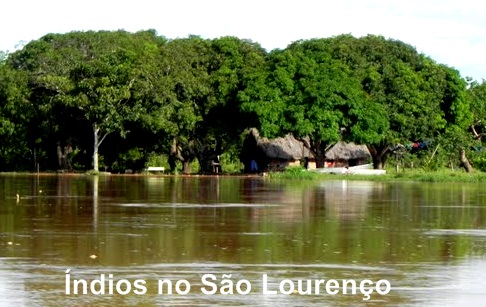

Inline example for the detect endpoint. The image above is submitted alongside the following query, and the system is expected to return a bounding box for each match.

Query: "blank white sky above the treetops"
[0,0,486,81]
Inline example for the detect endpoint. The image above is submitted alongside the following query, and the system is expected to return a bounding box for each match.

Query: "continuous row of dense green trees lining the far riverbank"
[0,30,486,172]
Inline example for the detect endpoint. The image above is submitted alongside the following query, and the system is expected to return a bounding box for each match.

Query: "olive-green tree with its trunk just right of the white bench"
[139,36,211,173]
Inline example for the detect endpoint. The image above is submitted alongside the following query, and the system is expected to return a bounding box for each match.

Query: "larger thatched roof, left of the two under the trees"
[250,128,312,160]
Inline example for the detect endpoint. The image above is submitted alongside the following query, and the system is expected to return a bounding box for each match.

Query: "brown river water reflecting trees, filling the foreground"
[0,175,486,306]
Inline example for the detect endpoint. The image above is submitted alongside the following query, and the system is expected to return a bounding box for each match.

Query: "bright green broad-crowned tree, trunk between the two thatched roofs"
[242,39,388,167]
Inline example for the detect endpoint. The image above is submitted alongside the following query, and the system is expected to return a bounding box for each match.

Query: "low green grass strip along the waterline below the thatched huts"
[269,168,486,182]
